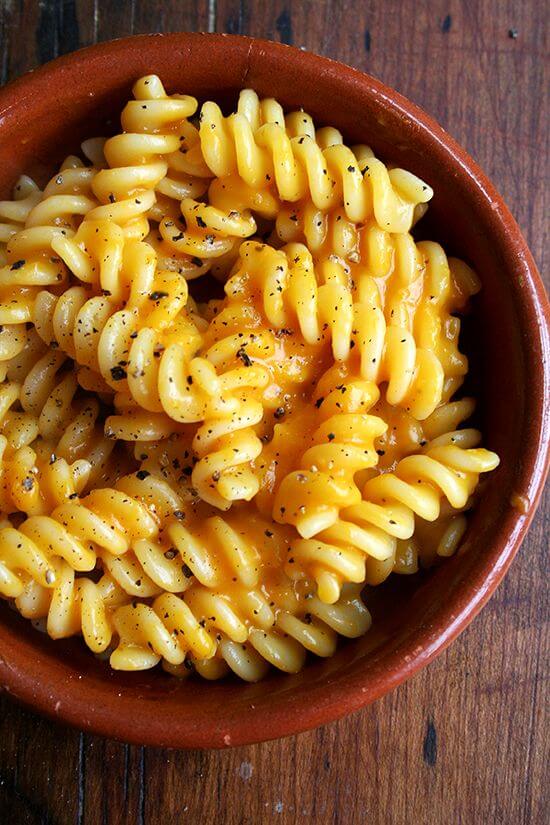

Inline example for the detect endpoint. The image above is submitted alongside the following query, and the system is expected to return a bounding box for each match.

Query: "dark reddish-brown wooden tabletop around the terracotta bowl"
[0,0,550,825]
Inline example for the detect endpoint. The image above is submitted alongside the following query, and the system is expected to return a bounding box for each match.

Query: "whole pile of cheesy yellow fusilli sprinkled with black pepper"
[0,76,498,681]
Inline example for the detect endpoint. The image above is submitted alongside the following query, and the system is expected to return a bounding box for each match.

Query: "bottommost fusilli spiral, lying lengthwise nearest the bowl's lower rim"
[111,576,371,682]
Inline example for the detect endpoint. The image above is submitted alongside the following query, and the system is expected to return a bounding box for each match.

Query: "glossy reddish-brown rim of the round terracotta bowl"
[0,32,550,748]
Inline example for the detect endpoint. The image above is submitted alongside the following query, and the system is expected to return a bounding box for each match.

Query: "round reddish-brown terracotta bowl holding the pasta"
[0,34,550,747]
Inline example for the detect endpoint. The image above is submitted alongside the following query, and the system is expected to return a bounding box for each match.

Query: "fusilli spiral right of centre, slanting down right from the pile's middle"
[226,242,452,419]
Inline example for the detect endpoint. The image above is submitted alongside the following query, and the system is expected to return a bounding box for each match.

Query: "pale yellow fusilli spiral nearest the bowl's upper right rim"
[200,90,433,232]
